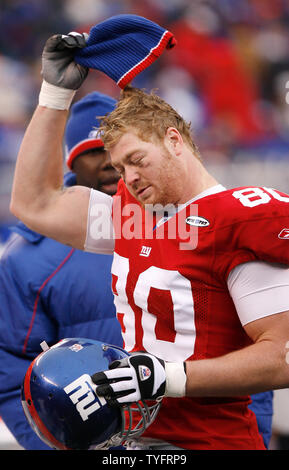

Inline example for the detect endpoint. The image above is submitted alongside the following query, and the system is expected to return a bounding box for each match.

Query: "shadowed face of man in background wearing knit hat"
[73,149,119,195]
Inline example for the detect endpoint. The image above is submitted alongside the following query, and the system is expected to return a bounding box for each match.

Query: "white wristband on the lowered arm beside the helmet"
[165,362,187,397]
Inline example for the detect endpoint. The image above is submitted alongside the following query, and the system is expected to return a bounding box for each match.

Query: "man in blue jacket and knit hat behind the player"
[0,93,122,450]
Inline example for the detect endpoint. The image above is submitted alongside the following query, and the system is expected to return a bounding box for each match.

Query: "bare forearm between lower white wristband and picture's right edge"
[186,341,289,397]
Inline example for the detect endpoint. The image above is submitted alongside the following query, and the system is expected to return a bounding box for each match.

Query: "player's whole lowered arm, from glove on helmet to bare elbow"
[92,311,289,404]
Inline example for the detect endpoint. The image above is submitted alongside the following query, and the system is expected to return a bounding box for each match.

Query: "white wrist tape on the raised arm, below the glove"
[39,80,77,109]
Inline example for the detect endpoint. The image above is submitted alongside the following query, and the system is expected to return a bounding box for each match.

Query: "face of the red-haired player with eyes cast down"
[110,132,183,206]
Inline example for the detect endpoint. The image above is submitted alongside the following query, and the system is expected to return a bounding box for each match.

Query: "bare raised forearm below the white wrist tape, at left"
[11,106,68,222]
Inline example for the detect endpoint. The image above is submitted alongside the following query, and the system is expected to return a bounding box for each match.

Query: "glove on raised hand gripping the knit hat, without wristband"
[41,33,89,90]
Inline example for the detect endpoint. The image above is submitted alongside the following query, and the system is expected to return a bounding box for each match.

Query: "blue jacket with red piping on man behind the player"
[0,235,122,450]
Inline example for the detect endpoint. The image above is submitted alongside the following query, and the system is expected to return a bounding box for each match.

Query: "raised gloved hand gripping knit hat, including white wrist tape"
[39,32,89,109]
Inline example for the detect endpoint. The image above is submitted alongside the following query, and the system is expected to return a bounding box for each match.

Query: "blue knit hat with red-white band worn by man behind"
[65,92,116,170]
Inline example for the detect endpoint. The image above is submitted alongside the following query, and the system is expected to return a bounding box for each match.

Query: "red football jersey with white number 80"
[112,182,289,449]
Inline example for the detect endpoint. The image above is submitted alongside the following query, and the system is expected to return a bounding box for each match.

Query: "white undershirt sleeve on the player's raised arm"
[84,189,114,254]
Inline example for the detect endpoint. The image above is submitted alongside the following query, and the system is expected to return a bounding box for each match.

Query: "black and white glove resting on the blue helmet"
[91,352,166,406]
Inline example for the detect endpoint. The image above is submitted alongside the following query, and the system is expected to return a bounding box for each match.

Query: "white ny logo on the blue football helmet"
[64,374,106,421]
